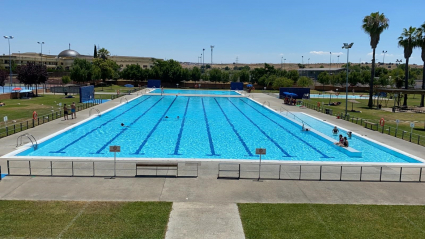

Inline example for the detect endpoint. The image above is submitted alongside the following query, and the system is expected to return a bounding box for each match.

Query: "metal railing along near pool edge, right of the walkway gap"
[217,163,424,182]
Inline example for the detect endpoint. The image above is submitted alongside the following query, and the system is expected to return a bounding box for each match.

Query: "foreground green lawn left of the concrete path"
[0,201,172,238]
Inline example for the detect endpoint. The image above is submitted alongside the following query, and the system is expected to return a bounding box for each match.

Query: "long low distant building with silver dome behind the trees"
[0,46,159,71]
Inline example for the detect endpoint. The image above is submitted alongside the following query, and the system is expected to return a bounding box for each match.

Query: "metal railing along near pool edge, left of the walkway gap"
[7,159,199,178]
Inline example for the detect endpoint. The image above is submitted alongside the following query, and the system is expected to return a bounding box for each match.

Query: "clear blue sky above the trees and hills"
[0,0,425,65]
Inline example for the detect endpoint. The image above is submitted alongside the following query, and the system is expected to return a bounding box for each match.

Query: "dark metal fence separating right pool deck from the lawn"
[303,102,425,146]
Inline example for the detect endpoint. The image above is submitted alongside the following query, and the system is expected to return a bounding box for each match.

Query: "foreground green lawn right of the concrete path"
[238,204,425,239]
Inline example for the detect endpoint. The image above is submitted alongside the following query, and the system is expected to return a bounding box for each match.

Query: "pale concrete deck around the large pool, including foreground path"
[0,93,425,238]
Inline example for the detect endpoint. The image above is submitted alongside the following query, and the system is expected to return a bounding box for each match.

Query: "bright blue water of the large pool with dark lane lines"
[18,95,417,163]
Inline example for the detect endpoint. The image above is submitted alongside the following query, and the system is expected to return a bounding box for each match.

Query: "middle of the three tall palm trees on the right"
[398,26,416,106]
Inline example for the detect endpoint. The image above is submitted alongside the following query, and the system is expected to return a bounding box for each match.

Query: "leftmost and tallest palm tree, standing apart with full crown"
[362,12,389,108]
